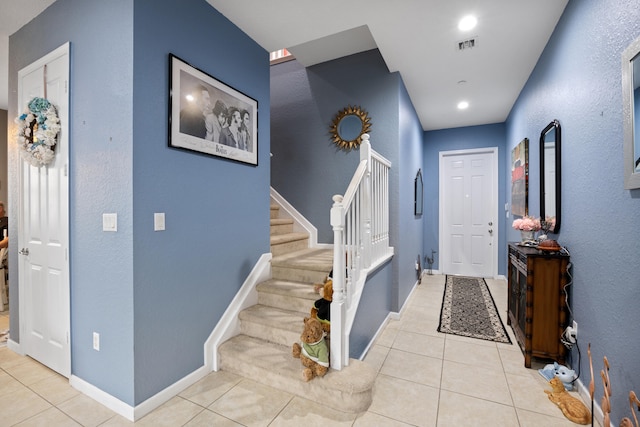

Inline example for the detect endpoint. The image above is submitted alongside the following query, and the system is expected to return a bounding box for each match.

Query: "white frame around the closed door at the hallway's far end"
[438,147,500,277]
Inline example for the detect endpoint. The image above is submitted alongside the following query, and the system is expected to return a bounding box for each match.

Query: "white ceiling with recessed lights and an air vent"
[0,0,568,130]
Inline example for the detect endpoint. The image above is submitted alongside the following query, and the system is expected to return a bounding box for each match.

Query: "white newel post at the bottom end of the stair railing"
[329,194,349,371]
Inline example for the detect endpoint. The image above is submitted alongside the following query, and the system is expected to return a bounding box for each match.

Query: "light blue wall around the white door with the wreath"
[9,0,134,404]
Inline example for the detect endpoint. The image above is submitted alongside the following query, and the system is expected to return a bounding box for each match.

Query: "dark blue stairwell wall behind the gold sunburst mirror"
[271,50,399,243]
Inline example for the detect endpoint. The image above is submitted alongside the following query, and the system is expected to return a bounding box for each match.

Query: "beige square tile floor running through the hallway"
[0,275,596,427]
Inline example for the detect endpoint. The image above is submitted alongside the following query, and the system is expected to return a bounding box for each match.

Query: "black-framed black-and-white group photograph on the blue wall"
[169,54,258,166]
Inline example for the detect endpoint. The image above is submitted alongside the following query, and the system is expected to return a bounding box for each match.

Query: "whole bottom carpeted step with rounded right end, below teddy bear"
[219,335,376,413]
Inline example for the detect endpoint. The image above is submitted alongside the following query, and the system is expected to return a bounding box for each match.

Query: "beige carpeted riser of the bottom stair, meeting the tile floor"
[220,352,373,413]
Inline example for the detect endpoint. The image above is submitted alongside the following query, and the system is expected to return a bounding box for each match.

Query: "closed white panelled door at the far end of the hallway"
[439,148,498,277]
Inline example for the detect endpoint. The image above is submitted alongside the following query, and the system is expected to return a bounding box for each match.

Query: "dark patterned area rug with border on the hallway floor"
[438,276,511,344]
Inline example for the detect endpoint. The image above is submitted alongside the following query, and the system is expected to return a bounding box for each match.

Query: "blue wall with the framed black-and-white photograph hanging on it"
[133,0,270,402]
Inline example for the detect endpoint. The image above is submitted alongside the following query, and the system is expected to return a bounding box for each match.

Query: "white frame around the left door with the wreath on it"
[16,43,71,377]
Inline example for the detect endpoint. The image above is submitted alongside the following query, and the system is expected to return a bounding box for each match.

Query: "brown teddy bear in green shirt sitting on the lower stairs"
[292,317,329,381]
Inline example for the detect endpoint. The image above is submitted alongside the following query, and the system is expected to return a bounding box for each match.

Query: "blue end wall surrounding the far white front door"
[424,123,508,276]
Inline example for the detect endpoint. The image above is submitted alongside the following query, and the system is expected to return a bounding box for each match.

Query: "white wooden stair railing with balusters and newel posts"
[330,134,393,370]
